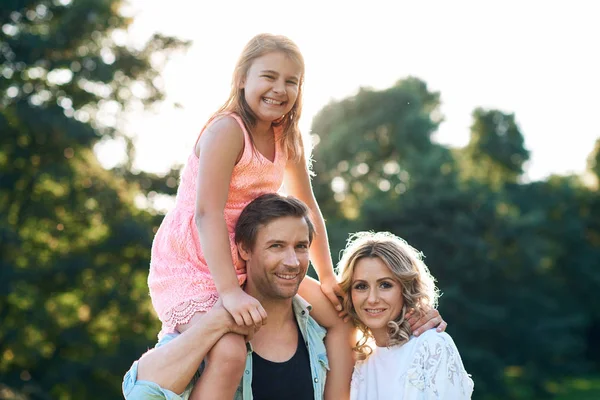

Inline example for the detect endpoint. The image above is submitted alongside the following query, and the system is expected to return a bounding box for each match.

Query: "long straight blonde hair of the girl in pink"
[213,33,304,160]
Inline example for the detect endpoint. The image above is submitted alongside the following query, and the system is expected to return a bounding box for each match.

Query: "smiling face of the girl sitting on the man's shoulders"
[241,51,302,123]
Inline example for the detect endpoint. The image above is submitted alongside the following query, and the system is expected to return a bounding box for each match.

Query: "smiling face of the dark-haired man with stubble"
[238,217,310,300]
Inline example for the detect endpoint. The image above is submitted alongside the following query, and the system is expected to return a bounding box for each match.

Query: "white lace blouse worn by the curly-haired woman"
[351,329,473,400]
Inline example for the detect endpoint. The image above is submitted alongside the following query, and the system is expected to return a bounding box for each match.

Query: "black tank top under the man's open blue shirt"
[252,322,314,400]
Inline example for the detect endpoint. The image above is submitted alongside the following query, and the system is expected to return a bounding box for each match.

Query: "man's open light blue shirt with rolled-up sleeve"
[123,296,329,400]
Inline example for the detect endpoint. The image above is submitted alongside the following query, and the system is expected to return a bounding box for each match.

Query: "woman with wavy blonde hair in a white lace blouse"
[339,232,473,400]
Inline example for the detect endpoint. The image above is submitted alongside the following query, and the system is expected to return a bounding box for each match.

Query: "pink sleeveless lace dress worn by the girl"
[148,114,287,334]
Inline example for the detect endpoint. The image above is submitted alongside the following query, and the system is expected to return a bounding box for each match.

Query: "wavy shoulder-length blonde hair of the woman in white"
[338,232,439,359]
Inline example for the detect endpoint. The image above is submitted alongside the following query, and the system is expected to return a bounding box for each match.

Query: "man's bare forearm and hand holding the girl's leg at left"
[137,301,252,394]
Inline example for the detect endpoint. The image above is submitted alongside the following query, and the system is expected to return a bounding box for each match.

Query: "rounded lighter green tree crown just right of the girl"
[312,78,441,225]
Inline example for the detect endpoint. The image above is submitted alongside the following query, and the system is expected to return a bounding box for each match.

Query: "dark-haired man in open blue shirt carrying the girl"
[123,194,441,400]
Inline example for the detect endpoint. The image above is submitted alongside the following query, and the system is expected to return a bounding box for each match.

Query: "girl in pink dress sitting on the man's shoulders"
[148,34,353,399]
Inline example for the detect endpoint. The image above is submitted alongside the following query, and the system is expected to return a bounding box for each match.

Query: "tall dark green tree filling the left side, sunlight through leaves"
[0,0,186,399]
